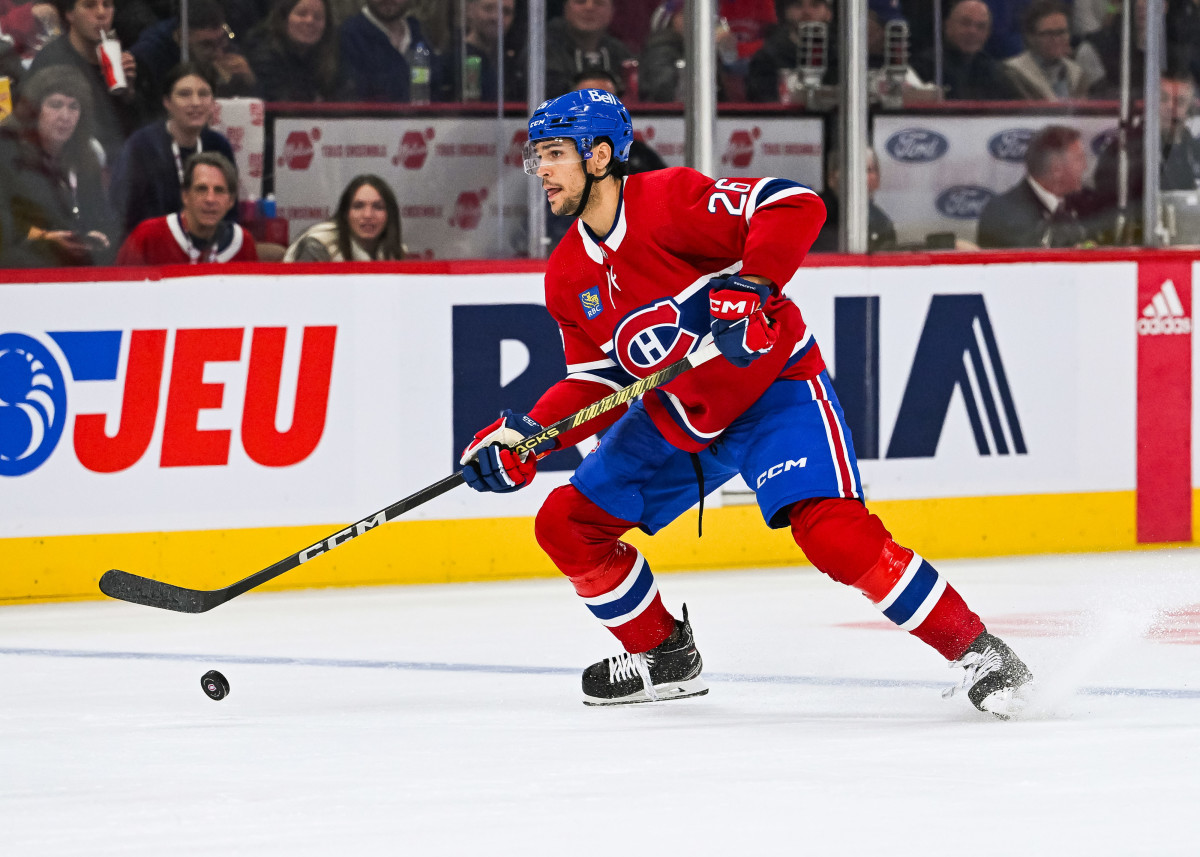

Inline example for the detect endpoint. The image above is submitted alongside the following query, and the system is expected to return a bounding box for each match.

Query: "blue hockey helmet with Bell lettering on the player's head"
[524,89,634,175]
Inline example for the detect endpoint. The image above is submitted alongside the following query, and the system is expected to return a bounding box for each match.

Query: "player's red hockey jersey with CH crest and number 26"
[530,168,824,451]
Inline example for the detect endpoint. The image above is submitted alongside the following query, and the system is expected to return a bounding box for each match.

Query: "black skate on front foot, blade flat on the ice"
[583,597,708,706]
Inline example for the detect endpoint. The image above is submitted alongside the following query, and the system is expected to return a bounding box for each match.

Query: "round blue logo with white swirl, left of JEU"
[0,334,67,477]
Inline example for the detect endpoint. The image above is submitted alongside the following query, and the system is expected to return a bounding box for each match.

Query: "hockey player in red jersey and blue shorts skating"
[462,89,1032,718]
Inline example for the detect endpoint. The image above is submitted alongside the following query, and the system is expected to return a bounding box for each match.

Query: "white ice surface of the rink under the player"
[0,550,1200,857]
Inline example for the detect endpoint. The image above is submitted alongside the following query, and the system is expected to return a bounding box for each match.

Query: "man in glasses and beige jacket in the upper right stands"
[1004,0,1087,101]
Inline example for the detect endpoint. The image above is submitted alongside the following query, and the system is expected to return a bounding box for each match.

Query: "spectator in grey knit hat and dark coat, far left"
[0,65,113,268]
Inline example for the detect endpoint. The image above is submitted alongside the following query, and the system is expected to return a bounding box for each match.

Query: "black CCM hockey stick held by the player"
[100,342,720,613]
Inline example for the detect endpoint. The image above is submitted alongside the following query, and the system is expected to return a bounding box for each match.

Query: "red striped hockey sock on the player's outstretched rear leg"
[788,498,984,660]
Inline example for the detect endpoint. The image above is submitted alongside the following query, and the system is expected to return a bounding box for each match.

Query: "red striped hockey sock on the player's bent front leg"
[534,485,674,652]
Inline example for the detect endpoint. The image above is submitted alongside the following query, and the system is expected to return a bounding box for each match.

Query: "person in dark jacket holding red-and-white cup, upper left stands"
[29,0,142,167]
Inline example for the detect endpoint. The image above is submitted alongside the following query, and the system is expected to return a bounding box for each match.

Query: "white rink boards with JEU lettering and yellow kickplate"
[0,252,1200,603]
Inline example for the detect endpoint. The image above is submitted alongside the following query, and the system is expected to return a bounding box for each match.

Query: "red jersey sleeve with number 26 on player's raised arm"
[656,169,826,289]
